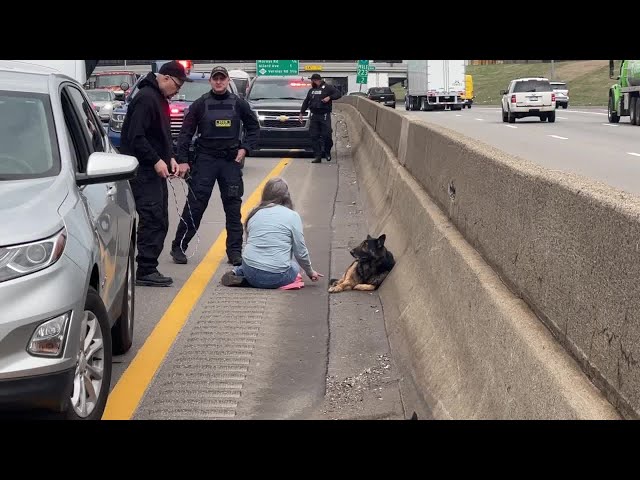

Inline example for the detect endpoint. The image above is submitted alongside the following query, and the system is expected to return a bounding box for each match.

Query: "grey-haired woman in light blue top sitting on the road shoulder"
[221,177,323,288]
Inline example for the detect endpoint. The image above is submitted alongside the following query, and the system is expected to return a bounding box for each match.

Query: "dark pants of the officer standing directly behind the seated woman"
[172,149,244,257]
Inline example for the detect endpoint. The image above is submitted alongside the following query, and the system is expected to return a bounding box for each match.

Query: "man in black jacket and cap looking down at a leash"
[120,61,191,287]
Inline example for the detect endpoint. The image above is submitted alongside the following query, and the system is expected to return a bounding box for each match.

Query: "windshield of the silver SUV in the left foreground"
[0,91,60,180]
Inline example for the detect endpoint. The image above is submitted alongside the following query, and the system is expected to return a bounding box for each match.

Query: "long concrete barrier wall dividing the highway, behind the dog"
[336,97,640,418]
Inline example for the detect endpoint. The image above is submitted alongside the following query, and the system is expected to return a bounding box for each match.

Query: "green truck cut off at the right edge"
[607,60,640,125]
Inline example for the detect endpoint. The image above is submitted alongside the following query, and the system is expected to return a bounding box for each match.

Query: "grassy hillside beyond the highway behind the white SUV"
[391,60,619,107]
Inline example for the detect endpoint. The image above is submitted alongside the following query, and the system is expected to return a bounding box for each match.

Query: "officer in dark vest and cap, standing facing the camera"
[171,66,260,266]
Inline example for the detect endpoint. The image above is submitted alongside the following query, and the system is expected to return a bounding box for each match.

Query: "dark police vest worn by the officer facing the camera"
[199,93,241,140]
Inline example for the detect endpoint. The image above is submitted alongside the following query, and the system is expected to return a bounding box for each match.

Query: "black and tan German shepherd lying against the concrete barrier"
[329,233,396,293]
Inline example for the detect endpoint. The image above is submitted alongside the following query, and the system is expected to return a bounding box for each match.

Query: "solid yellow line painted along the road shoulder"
[102,158,291,420]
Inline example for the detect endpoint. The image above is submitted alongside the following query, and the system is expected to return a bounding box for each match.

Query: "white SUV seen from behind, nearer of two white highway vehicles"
[500,77,556,123]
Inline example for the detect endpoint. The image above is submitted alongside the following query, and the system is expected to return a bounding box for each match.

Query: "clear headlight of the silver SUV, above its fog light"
[0,228,67,282]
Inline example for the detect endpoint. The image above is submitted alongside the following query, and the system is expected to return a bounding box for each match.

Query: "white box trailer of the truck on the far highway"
[404,60,465,111]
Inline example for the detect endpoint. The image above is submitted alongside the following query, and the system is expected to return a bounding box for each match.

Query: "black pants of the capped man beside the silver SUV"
[130,168,169,277]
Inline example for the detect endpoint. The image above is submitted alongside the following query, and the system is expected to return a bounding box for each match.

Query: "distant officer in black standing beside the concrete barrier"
[300,73,342,163]
